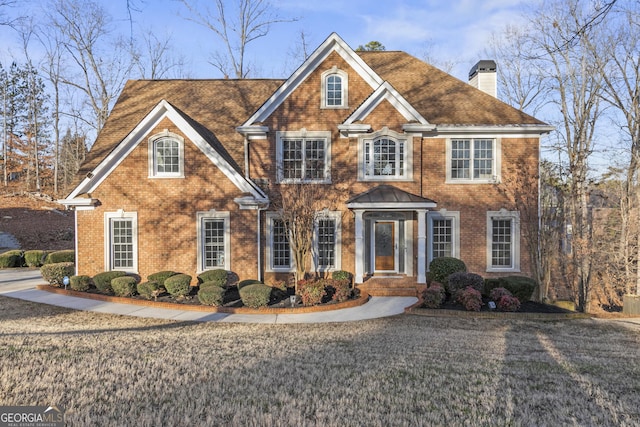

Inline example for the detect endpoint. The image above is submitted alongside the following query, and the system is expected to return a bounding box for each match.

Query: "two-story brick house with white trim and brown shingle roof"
[58,34,551,283]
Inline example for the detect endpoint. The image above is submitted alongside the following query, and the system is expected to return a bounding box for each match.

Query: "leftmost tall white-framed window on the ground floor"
[105,211,138,272]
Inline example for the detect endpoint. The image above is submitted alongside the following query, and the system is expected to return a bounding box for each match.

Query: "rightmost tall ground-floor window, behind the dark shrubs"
[487,209,520,272]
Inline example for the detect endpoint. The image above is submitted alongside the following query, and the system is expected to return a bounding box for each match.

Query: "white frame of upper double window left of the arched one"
[276,129,331,184]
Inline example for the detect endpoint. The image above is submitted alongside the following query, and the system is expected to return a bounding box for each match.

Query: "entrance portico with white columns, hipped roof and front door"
[347,185,437,283]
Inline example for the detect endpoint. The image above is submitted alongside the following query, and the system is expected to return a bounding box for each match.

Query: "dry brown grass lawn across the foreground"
[0,297,640,426]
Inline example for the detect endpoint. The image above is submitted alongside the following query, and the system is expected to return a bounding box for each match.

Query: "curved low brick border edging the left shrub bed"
[36,285,369,314]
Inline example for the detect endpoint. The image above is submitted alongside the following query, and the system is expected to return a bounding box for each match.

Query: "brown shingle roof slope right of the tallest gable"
[358,52,544,126]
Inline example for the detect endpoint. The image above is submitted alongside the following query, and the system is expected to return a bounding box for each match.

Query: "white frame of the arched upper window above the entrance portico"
[358,127,413,181]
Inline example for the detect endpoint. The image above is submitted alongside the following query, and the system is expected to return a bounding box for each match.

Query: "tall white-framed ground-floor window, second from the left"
[197,211,231,271]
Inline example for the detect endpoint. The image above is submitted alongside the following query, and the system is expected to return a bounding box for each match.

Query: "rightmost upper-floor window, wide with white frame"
[447,138,499,182]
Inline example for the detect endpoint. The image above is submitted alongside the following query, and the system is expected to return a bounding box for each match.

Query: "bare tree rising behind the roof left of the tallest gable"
[181,0,295,79]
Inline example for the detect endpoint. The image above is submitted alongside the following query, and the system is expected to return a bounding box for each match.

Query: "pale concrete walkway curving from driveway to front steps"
[0,268,418,323]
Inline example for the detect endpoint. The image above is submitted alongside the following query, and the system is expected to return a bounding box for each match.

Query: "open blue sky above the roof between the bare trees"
[103,0,526,80]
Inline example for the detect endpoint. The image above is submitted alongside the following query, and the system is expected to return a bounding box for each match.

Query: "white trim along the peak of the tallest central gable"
[242,33,383,127]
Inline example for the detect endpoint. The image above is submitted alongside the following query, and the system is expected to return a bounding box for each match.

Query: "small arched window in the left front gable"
[149,131,184,178]
